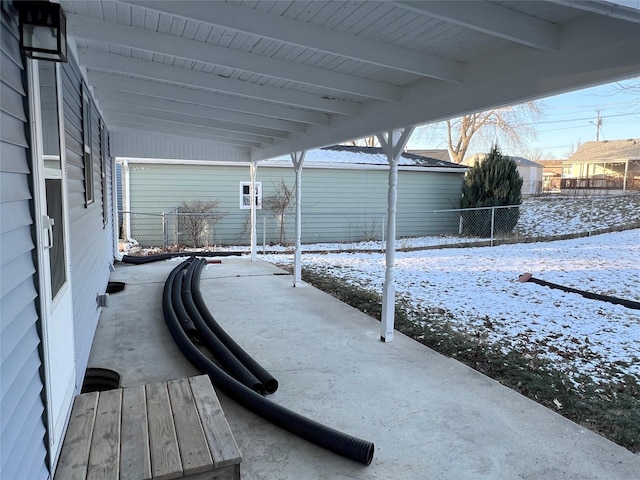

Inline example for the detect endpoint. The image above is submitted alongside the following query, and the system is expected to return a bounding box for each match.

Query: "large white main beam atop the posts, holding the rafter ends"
[251,10,640,161]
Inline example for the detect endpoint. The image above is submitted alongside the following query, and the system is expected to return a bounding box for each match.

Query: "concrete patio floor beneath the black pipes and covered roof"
[89,257,640,480]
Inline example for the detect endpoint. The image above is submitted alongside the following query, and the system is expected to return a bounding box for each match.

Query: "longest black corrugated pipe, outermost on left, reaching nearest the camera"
[162,261,375,465]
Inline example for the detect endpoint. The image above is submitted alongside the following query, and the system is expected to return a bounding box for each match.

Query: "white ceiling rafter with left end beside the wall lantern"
[67,14,401,102]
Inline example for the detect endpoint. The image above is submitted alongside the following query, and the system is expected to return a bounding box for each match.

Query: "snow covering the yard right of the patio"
[262,229,640,382]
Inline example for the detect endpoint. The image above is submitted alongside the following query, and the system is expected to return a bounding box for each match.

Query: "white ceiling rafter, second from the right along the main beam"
[392,0,560,51]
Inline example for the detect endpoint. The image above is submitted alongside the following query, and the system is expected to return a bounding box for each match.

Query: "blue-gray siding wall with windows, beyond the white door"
[62,56,113,385]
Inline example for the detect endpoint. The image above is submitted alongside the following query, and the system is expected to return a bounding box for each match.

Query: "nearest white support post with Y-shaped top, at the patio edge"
[377,127,414,342]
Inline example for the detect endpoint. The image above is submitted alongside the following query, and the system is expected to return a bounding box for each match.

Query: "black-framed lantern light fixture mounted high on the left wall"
[14,1,67,62]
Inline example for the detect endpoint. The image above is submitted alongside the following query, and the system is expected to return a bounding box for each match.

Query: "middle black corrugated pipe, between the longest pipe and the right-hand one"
[181,259,265,395]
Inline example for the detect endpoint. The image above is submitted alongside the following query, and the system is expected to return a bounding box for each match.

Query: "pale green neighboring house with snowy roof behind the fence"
[119,146,467,246]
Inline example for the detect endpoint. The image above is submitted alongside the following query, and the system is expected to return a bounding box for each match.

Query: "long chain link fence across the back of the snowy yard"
[120,194,640,251]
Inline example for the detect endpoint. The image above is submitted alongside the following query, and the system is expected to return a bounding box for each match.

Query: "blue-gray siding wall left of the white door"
[0,6,48,480]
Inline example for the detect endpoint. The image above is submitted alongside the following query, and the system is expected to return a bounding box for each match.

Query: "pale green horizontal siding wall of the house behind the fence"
[122,163,463,247]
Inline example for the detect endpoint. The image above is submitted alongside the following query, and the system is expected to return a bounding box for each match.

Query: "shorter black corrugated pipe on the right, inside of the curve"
[191,260,278,394]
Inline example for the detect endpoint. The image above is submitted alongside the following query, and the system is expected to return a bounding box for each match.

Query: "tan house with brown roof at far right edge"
[561,139,640,193]
